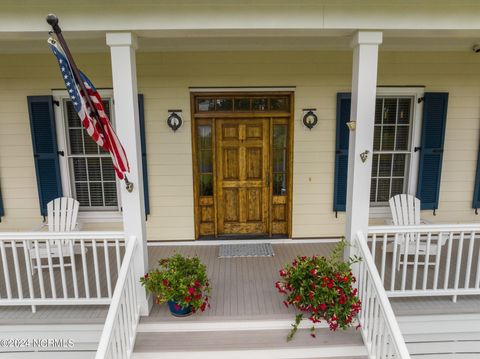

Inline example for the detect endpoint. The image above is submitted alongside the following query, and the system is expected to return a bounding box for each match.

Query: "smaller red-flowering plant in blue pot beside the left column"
[140,254,210,317]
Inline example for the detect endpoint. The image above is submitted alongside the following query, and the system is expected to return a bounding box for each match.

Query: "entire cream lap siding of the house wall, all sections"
[0,51,480,240]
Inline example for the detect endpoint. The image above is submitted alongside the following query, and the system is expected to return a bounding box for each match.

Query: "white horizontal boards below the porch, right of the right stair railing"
[397,314,480,359]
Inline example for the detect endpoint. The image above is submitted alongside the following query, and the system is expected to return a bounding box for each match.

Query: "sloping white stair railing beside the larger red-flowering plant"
[352,232,410,359]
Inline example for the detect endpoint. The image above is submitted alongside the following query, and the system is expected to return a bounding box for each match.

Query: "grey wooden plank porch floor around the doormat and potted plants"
[0,239,480,325]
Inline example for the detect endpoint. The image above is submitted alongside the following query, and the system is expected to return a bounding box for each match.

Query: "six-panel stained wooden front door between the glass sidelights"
[215,118,270,235]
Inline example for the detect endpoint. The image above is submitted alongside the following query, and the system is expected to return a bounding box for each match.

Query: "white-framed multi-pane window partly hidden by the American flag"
[54,91,120,217]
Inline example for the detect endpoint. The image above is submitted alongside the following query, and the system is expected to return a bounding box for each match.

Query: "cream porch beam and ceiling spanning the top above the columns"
[0,0,480,52]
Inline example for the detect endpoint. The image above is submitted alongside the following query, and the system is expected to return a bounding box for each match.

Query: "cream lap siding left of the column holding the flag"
[0,54,117,231]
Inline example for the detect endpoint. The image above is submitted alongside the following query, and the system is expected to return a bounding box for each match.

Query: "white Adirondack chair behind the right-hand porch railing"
[387,194,446,270]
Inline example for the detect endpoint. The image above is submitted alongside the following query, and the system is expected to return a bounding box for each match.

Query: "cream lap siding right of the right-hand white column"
[378,52,480,223]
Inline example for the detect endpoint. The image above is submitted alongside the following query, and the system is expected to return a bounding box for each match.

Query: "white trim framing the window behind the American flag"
[52,89,122,222]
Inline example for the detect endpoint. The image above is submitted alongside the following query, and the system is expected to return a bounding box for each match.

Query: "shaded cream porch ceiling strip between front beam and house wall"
[0,29,480,53]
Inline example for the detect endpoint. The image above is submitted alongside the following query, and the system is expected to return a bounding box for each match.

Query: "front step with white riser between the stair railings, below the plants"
[133,328,367,359]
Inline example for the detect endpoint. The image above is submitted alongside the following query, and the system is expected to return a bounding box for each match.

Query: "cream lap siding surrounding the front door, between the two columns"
[137,52,351,239]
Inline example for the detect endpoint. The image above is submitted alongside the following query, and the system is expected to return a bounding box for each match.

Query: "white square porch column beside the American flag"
[107,32,149,315]
